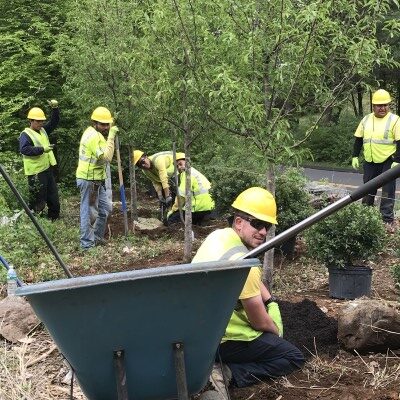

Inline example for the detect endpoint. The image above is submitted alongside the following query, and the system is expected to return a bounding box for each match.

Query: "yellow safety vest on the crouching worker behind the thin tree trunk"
[178,167,215,212]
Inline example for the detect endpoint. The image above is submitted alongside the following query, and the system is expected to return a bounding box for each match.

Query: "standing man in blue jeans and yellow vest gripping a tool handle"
[76,107,118,250]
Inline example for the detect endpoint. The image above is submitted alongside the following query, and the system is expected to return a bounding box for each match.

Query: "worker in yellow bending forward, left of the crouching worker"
[132,150,174,207]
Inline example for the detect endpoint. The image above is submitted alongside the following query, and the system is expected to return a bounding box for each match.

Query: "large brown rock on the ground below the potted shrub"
[338,299,400,352]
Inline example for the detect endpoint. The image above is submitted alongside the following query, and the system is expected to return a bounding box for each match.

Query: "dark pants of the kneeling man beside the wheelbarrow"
[216,332,304,387]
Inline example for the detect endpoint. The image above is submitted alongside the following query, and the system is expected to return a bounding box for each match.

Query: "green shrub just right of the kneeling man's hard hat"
[275,168,313,257]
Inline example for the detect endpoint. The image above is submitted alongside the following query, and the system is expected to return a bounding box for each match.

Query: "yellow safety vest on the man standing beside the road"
[354,112,400,163]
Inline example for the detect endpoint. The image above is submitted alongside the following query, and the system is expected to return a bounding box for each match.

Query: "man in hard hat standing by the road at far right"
[352,89,400,224]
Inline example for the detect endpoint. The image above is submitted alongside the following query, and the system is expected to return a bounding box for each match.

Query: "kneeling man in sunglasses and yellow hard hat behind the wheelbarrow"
[192,187,304,399]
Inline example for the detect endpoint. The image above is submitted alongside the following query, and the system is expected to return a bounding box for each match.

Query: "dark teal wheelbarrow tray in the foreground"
[17,259,259,400]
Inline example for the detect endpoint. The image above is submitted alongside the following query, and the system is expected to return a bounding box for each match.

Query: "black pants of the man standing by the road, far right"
[362,157,396,222]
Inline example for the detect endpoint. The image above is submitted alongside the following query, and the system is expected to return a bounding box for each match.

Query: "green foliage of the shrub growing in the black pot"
[305,203,386,268]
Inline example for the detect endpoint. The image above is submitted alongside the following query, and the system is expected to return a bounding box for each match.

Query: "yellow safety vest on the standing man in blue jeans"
[76,126,107,181]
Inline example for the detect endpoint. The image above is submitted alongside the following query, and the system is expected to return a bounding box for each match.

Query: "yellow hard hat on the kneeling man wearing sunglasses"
[232,187,278,224]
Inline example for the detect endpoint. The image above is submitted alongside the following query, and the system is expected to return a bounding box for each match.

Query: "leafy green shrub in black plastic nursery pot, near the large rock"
[306,203,386,299]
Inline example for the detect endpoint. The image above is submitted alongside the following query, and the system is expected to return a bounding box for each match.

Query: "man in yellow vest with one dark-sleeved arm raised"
[19,100,60,220]
